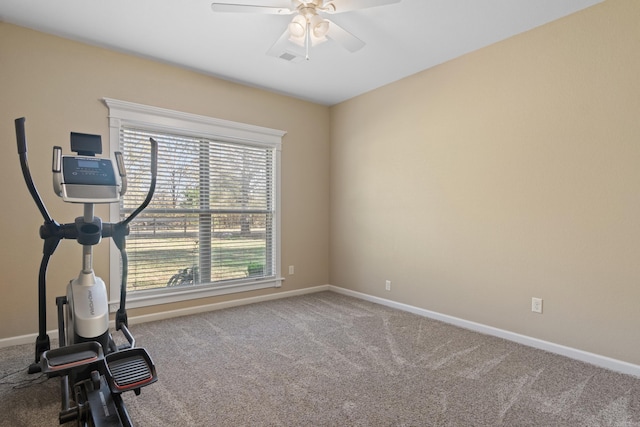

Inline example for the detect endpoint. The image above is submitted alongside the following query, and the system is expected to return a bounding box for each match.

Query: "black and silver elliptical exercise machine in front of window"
[15,118,158,427]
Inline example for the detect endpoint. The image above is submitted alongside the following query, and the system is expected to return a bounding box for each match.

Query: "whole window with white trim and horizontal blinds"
[104,99,284,307]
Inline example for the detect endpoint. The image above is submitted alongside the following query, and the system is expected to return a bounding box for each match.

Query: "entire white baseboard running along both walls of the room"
[0,285,640,378]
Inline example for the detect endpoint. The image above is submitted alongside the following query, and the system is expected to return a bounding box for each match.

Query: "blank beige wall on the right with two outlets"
[330,0,640,364]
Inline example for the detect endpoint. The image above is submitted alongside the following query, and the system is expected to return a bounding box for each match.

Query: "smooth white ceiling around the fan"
[0,0,603,105]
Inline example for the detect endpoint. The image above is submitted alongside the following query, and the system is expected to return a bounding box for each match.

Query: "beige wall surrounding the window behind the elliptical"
[0,23,330,339]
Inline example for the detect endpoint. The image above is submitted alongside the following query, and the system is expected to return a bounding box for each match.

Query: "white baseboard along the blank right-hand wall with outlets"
[329,285,640,377]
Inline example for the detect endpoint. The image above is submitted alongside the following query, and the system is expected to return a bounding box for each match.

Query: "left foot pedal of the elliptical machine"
[40,341,104,377]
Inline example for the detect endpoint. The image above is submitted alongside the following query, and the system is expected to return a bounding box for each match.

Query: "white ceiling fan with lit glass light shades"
[211,0,401,62]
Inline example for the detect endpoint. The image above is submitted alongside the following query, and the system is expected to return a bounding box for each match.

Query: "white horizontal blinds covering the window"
[119,126,276,290]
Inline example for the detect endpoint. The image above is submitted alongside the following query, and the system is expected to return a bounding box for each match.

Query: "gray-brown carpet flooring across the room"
[0,292,640,427]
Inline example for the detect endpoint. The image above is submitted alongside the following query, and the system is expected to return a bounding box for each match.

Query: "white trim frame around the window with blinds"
[102,98,286,312]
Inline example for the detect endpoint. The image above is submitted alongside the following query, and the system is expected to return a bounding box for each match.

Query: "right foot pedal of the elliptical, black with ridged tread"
[105,347,158,393]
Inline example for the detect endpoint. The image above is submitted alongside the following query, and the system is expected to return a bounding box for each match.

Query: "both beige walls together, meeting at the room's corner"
[0,0,640,364]
